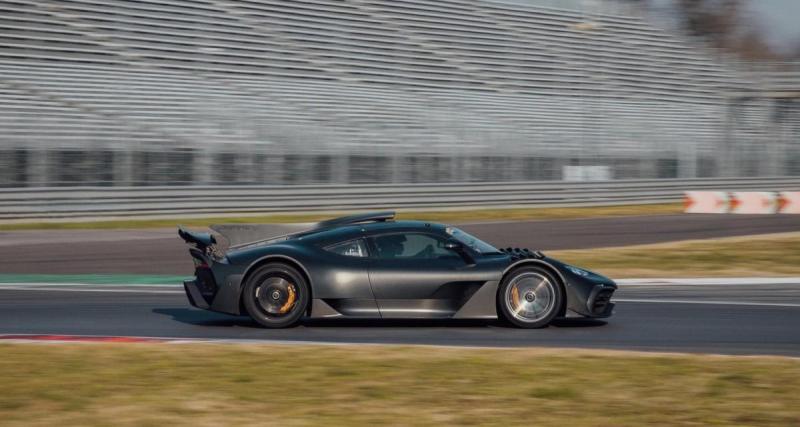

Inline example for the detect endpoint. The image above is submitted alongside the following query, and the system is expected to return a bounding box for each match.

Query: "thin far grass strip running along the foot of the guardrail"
[0,203,683,231]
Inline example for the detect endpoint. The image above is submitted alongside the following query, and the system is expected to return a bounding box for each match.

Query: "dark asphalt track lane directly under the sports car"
[0,283,800,356]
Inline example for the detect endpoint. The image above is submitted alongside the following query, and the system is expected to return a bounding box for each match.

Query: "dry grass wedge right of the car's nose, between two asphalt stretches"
[548,233,800,278]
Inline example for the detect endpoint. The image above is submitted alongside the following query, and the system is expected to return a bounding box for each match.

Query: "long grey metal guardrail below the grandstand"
[0,177,800,220]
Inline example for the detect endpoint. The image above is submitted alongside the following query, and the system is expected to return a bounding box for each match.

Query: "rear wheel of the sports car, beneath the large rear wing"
[242,263,310,328]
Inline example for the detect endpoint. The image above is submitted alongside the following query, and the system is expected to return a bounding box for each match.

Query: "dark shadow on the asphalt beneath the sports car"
[153,308,607,329]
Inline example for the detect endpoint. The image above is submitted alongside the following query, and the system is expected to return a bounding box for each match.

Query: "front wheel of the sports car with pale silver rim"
[497,266,564,329]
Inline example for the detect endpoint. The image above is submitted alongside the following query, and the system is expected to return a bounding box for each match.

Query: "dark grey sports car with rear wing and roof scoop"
[178,212,617,328]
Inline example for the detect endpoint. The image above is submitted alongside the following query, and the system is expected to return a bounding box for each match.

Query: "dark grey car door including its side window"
[368,231,483,318]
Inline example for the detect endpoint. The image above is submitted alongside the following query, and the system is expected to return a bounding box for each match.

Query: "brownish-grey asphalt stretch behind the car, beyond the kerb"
[0,215,800,274]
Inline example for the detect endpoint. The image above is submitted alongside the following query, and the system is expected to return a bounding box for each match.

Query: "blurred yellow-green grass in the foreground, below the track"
[0,344,800,426]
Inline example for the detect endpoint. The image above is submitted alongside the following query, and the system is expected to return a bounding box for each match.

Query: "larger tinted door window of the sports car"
[372,233,454,259]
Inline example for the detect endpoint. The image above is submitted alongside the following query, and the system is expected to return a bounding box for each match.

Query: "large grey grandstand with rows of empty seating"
[0,0,800,186]
